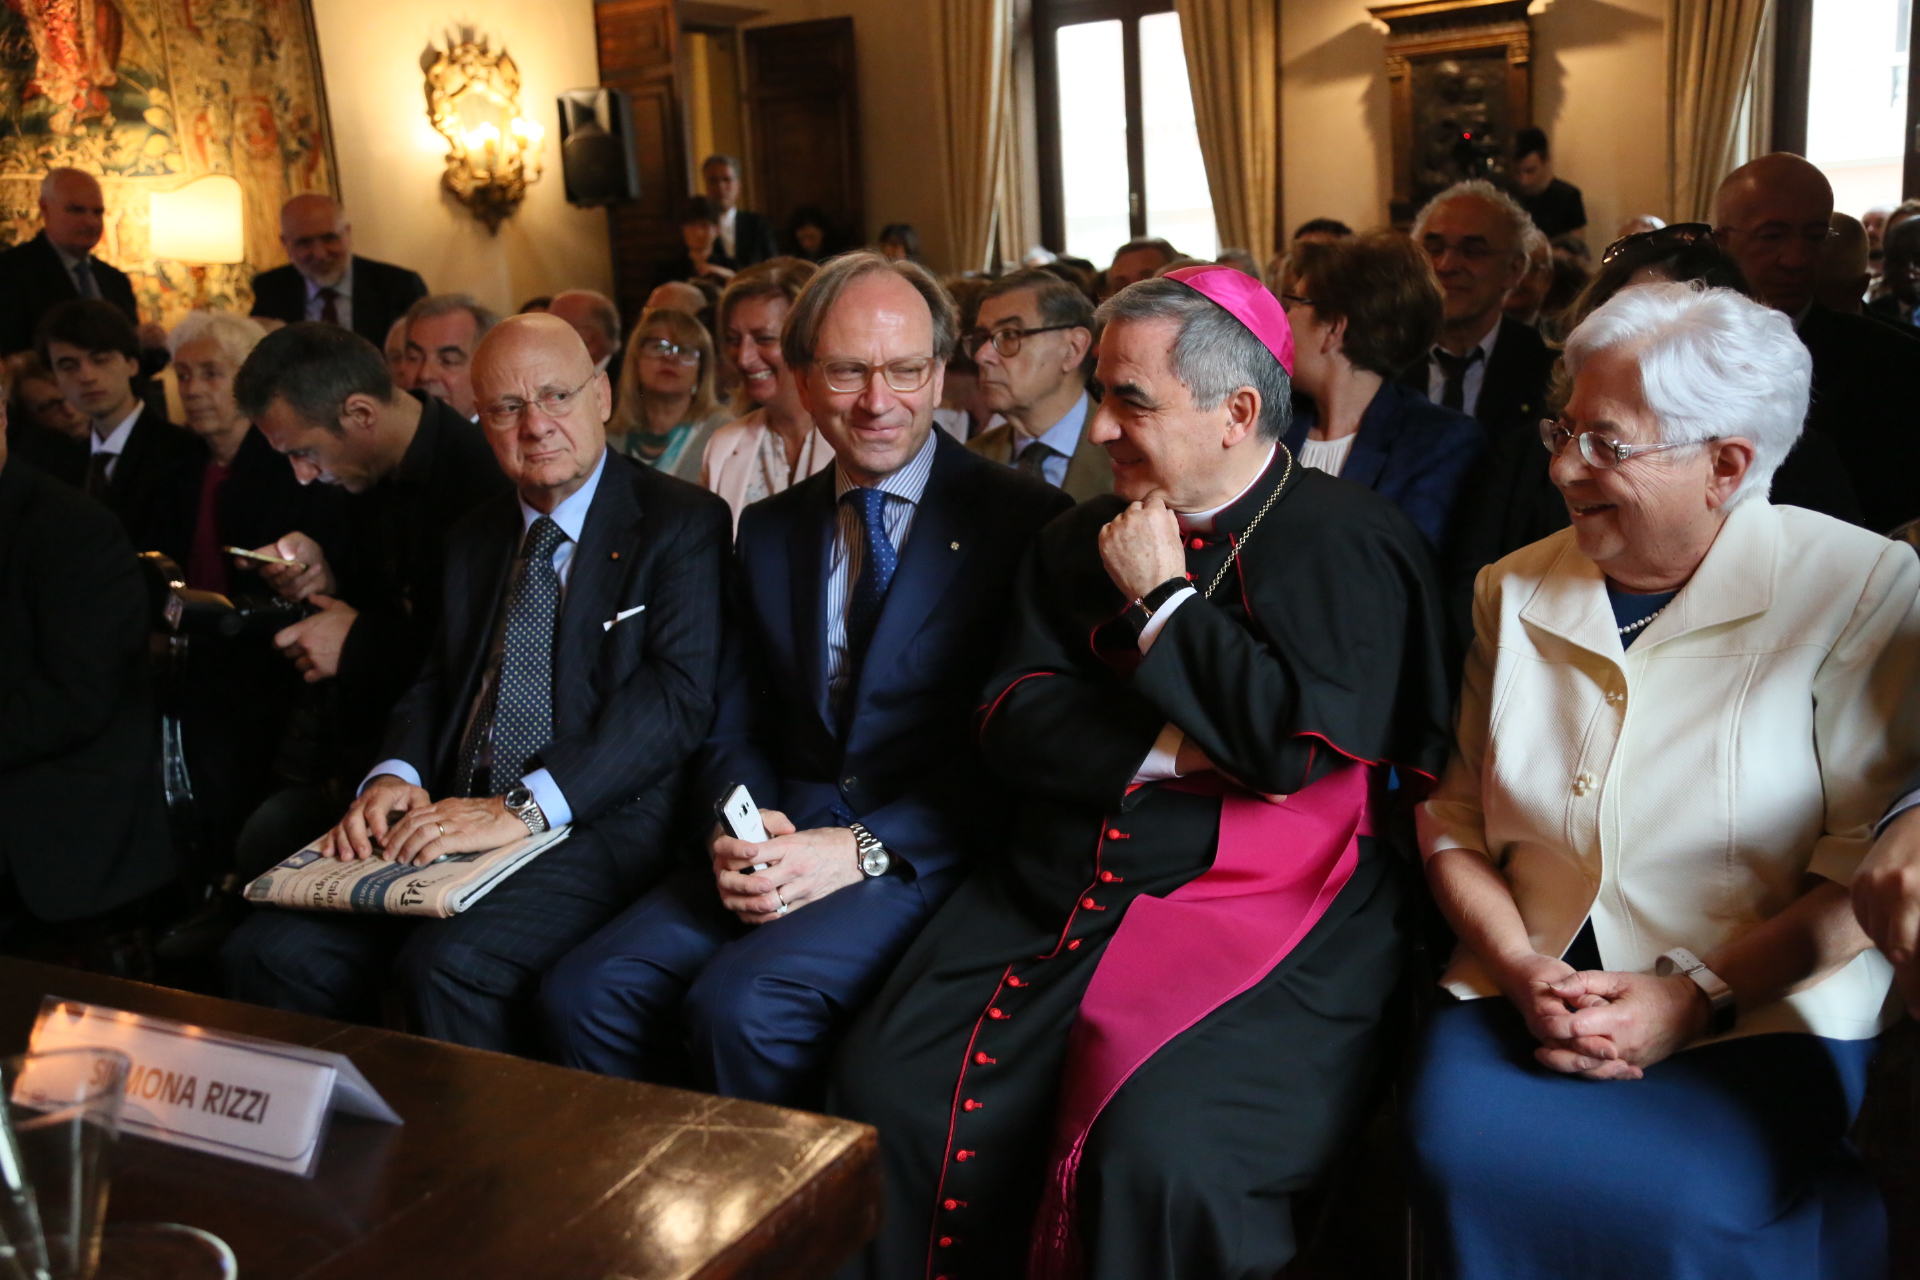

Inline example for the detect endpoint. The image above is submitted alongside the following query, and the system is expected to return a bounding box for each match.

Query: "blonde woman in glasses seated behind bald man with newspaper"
[607,307,732,484]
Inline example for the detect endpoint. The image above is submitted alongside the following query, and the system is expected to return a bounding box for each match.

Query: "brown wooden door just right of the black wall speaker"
[593,0,687,324]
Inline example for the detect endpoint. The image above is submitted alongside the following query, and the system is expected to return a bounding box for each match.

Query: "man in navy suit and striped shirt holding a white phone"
[541,251,1071,1105]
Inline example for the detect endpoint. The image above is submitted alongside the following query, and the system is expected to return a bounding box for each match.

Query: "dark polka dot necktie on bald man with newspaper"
[468,516,566,796]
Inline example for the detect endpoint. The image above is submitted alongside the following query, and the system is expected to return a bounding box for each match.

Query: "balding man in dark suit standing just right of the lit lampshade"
[253,194,426,347]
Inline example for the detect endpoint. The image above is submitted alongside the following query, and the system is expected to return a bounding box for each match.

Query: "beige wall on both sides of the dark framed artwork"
[1281,0,1667,248]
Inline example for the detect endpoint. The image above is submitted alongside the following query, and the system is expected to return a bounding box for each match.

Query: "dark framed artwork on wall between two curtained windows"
[1367,0,1532,226]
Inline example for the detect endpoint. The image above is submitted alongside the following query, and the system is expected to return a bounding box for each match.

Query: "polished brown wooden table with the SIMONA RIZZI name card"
[0,958,879,1280]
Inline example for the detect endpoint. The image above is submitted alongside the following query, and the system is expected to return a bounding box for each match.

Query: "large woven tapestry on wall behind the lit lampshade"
[0,0,338,324]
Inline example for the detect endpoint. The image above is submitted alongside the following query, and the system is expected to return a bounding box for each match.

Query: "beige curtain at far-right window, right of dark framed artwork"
[1667,0,1766,223]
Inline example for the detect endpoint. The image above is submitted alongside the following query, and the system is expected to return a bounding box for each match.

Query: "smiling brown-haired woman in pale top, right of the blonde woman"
[701,257,833,528]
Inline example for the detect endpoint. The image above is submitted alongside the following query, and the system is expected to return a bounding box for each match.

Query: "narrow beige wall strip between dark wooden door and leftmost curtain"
[751,0,960,271]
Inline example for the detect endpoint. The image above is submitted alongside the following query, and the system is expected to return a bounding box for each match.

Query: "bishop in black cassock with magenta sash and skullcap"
[835,267,1448,1280]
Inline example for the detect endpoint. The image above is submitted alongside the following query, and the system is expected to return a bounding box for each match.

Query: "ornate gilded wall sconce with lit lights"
[420,27,547,232]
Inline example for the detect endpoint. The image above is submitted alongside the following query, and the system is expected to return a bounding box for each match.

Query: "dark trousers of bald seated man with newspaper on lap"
[221,829,634,1057]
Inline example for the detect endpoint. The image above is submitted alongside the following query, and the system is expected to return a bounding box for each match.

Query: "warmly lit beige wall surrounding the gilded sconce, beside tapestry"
[313,0,612,311]
